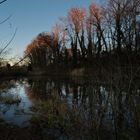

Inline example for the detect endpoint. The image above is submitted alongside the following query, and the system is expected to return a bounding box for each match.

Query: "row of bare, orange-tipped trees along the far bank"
[25,0,140,67]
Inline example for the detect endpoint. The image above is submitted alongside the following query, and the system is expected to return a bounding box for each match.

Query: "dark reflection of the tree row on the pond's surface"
[26,79,140,140]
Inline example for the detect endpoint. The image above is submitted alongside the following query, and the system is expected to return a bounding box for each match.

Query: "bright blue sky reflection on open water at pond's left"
[0,80,33,127]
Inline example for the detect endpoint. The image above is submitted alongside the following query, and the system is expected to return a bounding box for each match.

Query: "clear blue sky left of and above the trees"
[0,0,102,56]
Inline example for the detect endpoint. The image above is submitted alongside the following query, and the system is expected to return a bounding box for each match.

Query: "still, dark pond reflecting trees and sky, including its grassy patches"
[0,77,140,140]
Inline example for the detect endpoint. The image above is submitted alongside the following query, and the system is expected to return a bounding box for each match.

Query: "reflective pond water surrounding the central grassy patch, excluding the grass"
[0,78,140,139]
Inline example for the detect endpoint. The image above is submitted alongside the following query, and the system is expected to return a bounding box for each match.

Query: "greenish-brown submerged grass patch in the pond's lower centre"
[30,94,86,139]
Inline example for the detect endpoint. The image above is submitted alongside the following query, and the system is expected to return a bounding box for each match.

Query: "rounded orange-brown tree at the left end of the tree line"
[25,32,54,68]
